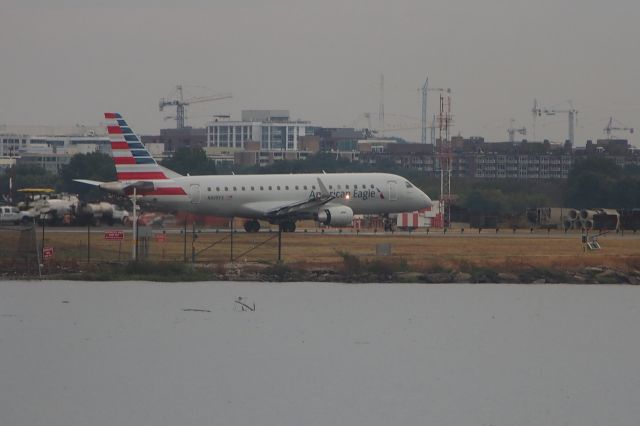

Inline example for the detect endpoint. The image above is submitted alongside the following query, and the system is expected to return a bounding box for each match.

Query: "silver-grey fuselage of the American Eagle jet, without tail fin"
[139,173,431,219]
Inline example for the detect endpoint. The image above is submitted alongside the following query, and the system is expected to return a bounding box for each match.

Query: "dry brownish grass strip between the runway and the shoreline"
[26,228,640,270]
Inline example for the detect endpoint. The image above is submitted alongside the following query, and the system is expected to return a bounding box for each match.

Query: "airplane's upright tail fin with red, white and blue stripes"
[104,112,179,182]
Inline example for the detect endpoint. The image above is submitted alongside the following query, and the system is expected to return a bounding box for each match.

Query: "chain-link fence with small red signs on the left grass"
[0,225,288,264]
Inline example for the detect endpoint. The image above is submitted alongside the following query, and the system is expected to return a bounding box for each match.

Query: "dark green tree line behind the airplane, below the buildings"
[0,148,640,215]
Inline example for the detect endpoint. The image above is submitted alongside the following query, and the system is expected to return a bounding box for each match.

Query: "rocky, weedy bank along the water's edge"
[5,256,640,285]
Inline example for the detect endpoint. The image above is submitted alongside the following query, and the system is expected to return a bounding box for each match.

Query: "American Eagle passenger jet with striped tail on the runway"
[75,112,431,232]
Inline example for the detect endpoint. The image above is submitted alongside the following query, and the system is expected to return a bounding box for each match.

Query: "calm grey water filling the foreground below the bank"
[0,281,640,426]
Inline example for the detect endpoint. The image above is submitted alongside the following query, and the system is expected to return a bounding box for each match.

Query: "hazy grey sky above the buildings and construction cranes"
[0,0,640,146]
